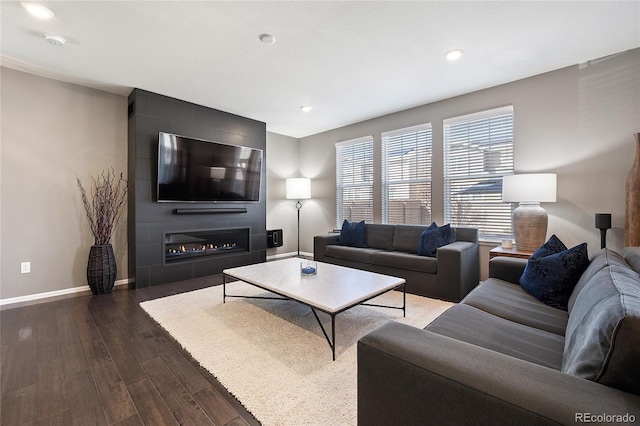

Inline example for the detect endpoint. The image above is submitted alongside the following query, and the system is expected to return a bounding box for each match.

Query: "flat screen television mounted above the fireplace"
[157,132,263,202]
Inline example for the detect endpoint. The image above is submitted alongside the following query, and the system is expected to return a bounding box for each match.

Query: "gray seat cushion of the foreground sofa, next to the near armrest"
[425,304,564,370]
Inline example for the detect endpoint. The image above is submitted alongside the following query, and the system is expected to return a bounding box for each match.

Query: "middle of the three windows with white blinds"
[382,124,432,225]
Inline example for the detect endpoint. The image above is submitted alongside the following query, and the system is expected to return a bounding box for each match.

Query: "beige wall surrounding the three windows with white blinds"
[300,49,640,277]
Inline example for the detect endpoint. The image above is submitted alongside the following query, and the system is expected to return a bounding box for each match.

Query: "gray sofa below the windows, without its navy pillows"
[313,223,480,302]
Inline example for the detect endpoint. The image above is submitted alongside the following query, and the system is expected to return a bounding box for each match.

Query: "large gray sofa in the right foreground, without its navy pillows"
[357,249,640,426]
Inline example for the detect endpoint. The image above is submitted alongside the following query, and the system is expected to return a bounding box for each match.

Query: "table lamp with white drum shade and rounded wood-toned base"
[502,173,557,251]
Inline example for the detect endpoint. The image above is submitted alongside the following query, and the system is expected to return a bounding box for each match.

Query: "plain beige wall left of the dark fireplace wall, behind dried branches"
[0,68,127,300]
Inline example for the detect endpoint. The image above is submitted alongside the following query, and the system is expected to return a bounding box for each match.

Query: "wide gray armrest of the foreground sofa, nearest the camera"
[358,322,640,425]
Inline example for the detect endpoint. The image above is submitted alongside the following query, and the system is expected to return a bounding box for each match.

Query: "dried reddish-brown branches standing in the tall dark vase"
[76,168,128,245]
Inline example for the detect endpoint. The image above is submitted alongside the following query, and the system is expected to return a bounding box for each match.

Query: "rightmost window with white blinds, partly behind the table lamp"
[444,106,513,240]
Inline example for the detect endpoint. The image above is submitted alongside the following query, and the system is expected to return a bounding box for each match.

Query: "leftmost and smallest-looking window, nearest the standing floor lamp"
[336,136,373,227]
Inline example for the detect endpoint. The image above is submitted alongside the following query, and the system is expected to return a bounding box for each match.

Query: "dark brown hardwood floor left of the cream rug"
[0,275,259,426]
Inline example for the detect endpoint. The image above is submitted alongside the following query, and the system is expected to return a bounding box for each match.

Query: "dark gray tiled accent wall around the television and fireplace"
[128,89,267,288]
